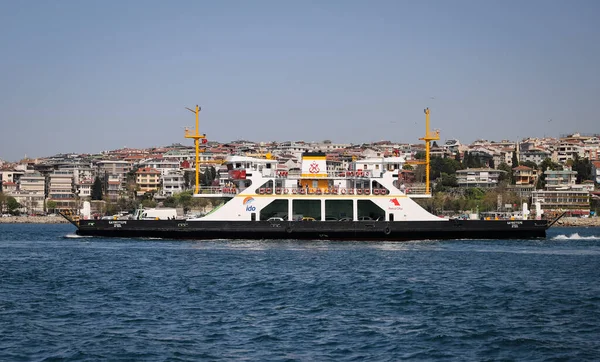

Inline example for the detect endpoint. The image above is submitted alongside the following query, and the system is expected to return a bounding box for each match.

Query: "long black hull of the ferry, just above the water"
[74,220,549,241]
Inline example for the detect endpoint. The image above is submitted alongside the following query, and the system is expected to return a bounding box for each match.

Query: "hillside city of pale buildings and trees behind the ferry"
[0,133,600,217]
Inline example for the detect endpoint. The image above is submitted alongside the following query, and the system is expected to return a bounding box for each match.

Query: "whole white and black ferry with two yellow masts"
[58,107,557,241]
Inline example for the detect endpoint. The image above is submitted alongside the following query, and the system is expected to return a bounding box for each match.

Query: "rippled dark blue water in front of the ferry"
[0,224,600,361]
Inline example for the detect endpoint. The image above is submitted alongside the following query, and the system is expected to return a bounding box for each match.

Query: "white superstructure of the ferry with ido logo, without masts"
[195,152,440,221]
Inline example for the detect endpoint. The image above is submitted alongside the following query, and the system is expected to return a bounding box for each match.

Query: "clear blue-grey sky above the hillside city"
[0,0,600,160]
